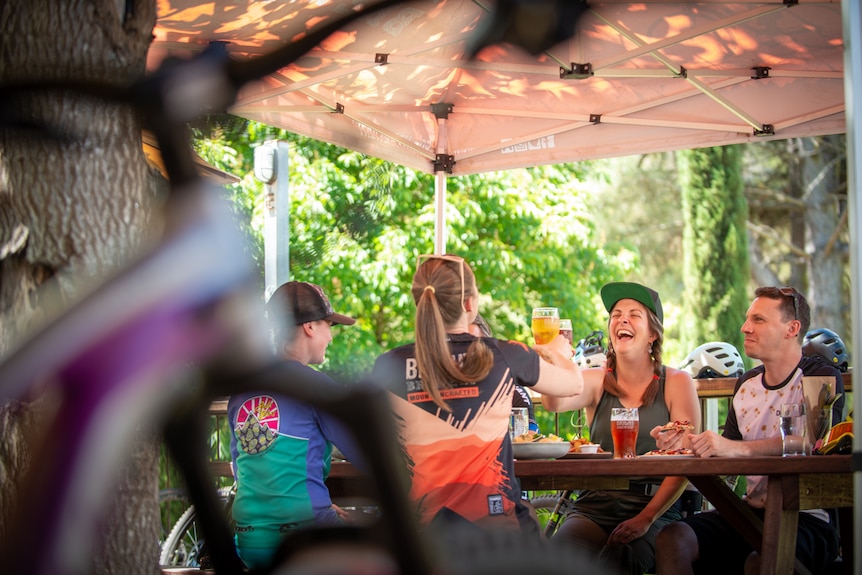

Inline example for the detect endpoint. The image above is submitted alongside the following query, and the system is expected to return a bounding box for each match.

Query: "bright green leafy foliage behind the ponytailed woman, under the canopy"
[240,127,626,378]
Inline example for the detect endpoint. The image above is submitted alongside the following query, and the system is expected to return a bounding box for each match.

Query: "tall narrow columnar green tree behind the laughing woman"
[677,146,749,358]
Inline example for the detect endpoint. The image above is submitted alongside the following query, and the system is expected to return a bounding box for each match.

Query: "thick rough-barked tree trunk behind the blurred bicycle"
[0,0,159,573]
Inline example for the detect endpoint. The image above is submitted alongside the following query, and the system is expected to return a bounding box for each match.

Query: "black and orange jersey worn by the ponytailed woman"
[374,334,539,529]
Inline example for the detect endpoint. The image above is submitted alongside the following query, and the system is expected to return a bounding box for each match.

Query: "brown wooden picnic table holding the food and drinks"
[327,455,853,574]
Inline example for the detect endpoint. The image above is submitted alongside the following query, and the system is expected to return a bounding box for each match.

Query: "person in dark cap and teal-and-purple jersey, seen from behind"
[228,282,358,569]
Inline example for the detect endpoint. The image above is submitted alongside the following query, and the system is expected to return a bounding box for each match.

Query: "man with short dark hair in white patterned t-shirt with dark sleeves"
[656,287,844,575]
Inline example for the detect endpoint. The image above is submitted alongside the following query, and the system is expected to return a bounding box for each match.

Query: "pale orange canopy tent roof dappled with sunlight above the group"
[150,0,846,175]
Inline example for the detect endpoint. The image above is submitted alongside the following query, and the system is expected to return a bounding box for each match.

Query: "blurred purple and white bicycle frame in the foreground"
[0,0,430,575]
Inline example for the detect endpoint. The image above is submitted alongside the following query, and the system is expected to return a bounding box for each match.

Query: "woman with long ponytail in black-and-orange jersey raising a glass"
[372,255,583,536]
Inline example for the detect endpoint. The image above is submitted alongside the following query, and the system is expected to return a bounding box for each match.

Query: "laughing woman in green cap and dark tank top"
[542,282,700,574]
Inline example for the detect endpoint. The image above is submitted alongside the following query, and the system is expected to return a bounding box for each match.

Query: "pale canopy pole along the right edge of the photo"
[841,2,862,573]
